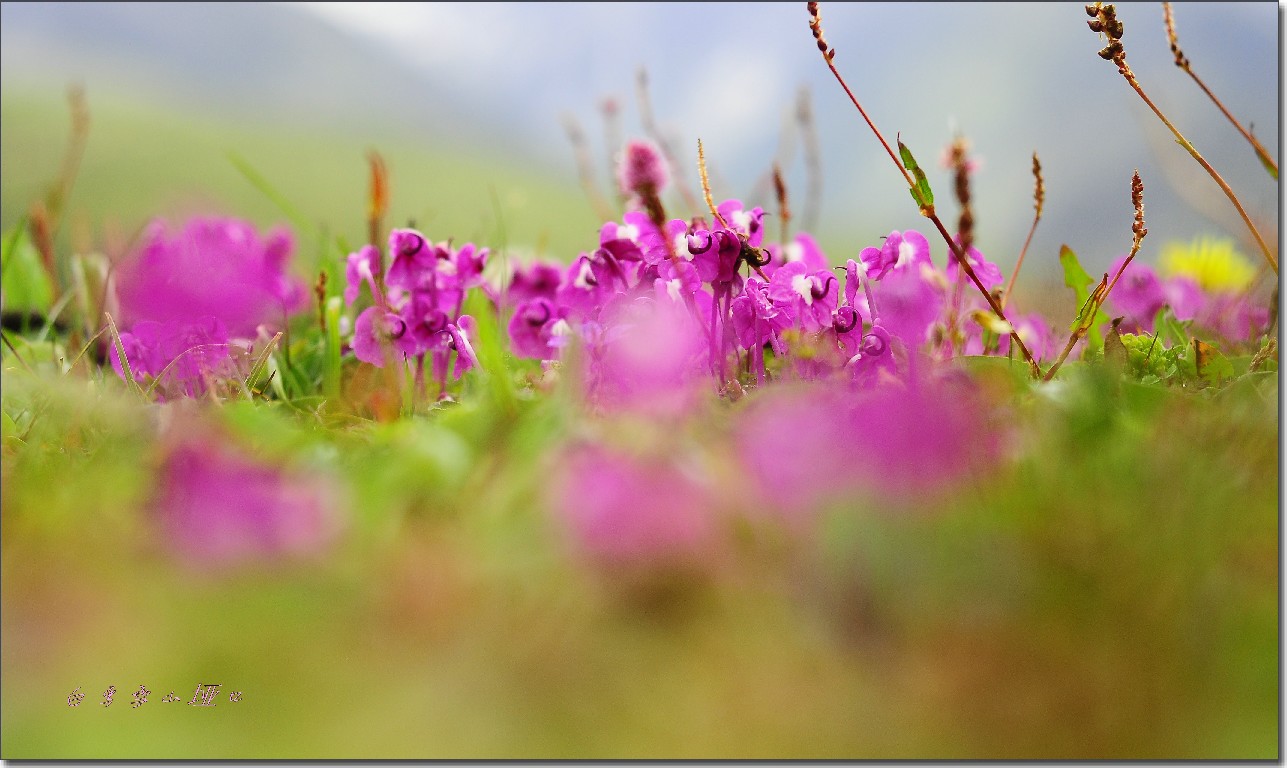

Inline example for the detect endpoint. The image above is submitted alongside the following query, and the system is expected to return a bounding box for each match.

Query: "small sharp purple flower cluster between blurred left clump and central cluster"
[344,229,488,386]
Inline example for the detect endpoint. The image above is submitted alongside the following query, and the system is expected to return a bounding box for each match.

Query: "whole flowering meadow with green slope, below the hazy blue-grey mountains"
[0,4,1281,760]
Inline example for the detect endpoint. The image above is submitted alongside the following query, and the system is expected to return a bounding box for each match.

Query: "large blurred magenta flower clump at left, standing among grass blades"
[108,219,304,396]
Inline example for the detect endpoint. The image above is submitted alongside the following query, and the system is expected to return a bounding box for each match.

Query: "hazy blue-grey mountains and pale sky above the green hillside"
[0,3,1279,276]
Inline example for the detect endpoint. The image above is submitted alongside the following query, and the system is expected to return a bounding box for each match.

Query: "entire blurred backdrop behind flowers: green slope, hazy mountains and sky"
[0,3,1281,289]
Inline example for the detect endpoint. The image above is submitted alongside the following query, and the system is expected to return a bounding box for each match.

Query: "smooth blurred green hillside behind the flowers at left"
[0,93,598,267]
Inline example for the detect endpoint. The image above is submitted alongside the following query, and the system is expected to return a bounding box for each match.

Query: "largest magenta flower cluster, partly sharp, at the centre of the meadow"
[506,199,1057,400]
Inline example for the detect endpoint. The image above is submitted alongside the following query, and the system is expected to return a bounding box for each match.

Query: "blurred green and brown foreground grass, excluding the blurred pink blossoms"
[0,355,1279,759]
